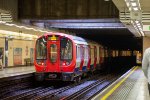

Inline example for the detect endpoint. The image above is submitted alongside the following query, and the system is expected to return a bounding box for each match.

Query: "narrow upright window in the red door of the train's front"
[50,44,57,62]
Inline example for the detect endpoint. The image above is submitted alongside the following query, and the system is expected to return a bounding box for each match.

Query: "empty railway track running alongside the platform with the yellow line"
[61,75,114,100]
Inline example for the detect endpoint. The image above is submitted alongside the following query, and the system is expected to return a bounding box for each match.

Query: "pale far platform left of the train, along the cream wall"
[0,66,35,78]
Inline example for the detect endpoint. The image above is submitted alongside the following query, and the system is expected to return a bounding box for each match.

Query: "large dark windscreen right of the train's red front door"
[60,38,73,60]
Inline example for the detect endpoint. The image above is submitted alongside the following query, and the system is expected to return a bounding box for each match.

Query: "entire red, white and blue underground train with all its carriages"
[34,32,138,82]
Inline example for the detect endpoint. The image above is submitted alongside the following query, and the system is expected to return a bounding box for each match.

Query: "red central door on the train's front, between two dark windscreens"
[47,40,60,72]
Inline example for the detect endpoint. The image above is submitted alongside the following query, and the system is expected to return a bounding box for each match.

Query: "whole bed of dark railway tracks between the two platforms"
[0,72,119,100]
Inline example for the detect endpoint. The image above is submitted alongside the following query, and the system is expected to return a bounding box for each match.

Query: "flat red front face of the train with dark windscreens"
[34,34,75,81]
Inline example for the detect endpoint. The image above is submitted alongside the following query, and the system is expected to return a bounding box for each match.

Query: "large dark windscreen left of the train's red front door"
[36,38,47,59]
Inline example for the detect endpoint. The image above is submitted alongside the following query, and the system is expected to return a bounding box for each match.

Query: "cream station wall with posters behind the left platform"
[0,38,35,67]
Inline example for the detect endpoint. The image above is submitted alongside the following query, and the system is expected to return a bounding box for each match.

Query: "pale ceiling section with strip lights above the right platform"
[112,0,150,37]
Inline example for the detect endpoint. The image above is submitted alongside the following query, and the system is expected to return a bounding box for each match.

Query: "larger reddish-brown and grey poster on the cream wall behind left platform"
[14,48,22,66]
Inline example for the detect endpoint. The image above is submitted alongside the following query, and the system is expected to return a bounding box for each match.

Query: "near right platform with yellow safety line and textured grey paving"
[92,67,150,100]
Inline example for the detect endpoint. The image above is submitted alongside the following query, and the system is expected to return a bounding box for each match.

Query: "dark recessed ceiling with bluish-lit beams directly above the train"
[23,18,142,50]
